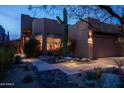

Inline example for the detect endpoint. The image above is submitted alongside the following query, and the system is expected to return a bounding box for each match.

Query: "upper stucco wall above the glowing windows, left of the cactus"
[32,18,63,35]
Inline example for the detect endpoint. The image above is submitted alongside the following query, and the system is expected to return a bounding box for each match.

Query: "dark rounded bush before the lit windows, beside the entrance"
[24,39,41,57]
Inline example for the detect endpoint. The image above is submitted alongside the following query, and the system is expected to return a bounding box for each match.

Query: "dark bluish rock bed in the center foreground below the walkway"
[32,69,78,88]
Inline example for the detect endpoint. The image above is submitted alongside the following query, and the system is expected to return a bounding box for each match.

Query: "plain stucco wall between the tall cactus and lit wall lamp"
[69,22,89,57]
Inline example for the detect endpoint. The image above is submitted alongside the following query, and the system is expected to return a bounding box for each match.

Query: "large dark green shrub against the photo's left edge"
[0,46,15,79]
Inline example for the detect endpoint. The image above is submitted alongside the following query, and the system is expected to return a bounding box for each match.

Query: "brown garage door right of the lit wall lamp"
[93,35,119,58]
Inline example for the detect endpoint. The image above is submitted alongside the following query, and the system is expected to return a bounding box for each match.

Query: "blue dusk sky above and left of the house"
[0,5,122,39]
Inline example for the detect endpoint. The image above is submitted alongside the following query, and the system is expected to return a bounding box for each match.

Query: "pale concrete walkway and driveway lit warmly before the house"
[22,58,124,75]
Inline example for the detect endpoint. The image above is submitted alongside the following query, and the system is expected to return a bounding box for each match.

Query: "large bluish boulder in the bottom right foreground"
[100,73,120,88]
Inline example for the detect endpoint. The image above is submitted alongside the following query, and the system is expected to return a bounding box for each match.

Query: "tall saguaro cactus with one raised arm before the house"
[56,8,68,56]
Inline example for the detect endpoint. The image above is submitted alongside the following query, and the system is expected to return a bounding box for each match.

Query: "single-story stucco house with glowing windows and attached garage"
[20,14,120,59]
